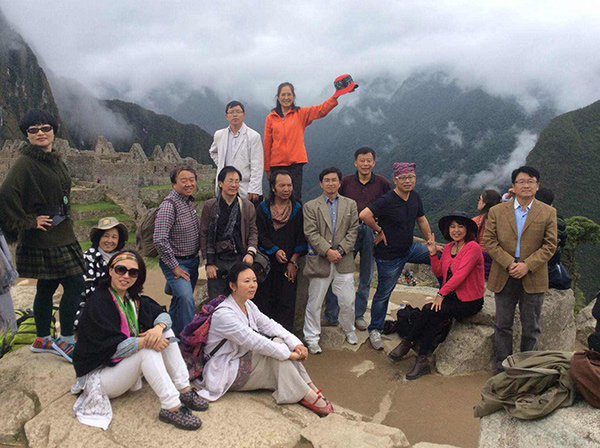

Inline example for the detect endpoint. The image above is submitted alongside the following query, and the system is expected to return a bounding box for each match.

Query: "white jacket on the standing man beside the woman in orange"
[209,123,264,198]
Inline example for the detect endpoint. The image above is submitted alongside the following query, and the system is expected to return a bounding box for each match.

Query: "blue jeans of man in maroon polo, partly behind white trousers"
[325,223,375,323]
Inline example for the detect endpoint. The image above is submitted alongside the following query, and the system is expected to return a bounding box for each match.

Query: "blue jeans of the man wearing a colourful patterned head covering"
[369,243,430,331]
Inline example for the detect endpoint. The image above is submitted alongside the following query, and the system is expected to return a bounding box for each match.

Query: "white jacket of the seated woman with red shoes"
[197,295,302,401]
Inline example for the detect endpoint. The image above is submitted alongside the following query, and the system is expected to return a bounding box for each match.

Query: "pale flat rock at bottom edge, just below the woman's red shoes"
[301,414,410,448]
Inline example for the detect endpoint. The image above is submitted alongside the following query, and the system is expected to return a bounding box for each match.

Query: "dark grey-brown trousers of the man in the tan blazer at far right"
[494,277,544,370]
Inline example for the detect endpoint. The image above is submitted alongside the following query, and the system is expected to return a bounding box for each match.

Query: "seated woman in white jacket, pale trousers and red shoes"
[198,262,333,415]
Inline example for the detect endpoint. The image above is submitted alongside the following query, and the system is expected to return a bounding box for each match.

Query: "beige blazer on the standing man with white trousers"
[303,195,358,278]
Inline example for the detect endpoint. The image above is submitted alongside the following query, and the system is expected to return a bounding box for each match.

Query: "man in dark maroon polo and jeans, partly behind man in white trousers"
[325,146,392,331]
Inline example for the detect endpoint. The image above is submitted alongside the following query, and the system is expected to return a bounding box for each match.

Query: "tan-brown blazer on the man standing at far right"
[483,199,557,294]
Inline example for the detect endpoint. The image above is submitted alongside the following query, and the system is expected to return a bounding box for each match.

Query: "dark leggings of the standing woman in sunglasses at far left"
[33,274,85,337]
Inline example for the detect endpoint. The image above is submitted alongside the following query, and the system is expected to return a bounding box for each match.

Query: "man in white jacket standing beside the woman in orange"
[209,101,263,203]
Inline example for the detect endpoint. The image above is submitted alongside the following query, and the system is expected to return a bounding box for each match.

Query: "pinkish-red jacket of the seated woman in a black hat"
[430,241,485,302]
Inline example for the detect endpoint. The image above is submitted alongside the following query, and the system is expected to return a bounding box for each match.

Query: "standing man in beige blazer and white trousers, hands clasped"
[304,167,358,354]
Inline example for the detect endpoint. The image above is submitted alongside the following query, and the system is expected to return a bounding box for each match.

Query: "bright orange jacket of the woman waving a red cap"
[264,97,338,171]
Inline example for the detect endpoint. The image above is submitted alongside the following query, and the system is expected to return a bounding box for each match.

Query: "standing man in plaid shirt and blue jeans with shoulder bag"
[153,165,200,336]
